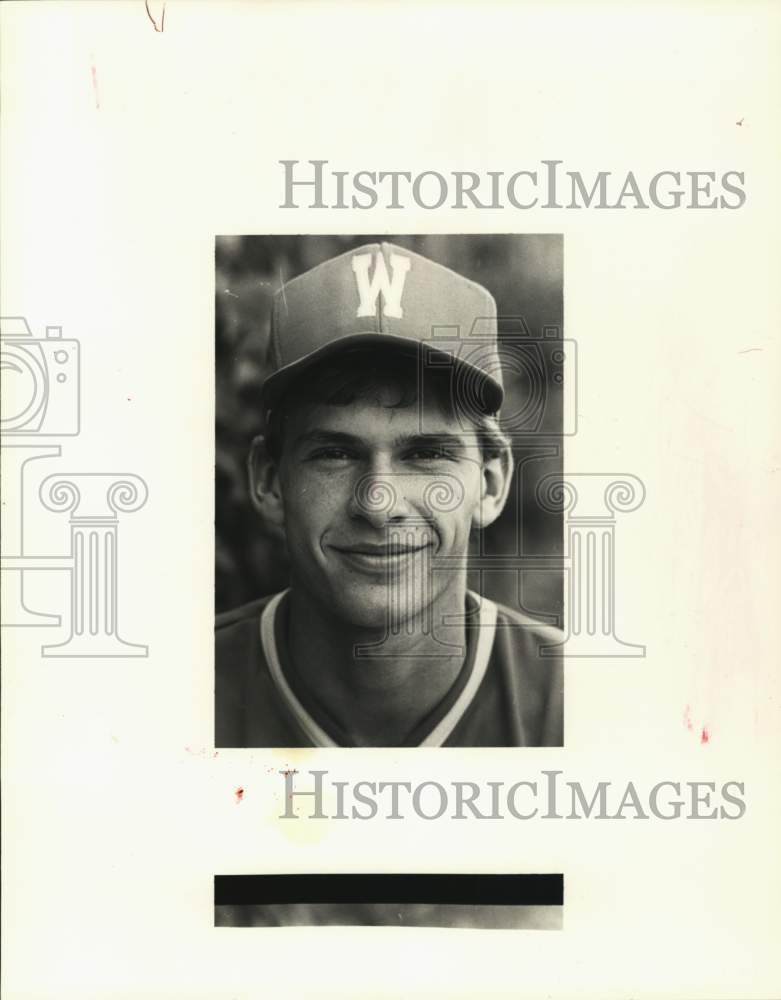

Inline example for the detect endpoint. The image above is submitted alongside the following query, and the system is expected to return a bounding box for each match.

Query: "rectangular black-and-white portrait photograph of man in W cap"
[215,234,565,747]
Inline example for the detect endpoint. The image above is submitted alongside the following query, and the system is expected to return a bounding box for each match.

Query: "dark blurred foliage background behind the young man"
[215,234,563,622]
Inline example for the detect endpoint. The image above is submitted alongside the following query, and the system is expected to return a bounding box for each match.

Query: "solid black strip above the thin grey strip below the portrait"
[214,874,564,906]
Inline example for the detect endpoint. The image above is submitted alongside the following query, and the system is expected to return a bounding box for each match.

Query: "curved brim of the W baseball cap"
[261,331,504,415]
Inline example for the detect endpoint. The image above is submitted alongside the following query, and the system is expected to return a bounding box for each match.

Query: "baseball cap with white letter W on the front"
[261,243,504,414]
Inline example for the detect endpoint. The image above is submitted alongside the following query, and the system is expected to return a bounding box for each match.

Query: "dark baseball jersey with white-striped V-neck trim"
[215,591,564,747]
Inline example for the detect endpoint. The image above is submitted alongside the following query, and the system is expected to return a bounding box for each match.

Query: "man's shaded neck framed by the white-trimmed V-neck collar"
[287,580,466,746]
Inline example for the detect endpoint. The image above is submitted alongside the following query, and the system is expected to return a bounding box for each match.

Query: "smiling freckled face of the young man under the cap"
[278,394,484,628]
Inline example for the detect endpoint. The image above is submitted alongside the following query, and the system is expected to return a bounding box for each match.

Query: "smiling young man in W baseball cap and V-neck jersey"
[216,243,563,747]
